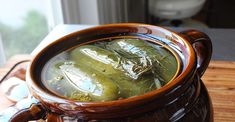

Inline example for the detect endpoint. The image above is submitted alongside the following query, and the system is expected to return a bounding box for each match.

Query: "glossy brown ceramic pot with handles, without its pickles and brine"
[6,23,213,122]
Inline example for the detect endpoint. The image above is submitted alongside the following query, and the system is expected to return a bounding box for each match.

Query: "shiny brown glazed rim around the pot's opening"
[26,23,196,107]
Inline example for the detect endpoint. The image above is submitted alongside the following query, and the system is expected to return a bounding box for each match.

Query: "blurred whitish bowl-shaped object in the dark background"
[149,0,206,19]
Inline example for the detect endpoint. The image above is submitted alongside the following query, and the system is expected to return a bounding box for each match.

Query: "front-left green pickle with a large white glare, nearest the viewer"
[59,61,119,101]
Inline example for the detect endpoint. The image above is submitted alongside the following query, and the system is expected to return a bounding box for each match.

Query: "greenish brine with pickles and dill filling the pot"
[42,39,179,102]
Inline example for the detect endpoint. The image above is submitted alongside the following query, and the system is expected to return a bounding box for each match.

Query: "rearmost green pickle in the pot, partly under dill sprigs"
[106,39,177,85]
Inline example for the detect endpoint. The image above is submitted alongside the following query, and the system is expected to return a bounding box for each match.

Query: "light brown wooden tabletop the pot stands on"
[0,55,235,122]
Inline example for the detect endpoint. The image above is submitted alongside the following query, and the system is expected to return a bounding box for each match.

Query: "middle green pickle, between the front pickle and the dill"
[71,45,156,98]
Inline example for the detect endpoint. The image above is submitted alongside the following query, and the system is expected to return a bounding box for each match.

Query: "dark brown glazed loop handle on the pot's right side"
[181,30,212,77]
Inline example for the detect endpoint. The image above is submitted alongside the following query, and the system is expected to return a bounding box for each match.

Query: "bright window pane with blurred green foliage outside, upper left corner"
[0,0,48,62]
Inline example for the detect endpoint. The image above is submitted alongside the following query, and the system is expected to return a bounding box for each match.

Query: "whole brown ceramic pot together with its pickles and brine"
[3,23,213,122]
